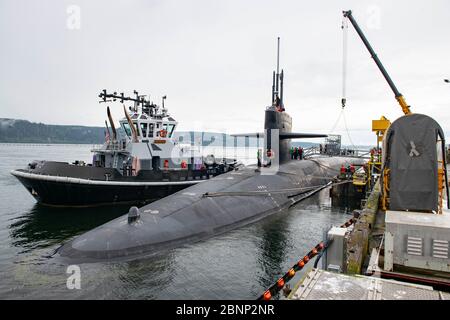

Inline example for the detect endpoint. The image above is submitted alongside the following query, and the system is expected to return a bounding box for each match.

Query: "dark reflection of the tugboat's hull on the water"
[9,204,129,252]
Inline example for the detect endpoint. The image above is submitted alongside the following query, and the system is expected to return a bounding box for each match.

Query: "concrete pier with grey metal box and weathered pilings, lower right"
[288,168,450,300]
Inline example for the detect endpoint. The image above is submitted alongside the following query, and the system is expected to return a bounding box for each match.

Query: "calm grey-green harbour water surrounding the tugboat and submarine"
[0,144,356,299]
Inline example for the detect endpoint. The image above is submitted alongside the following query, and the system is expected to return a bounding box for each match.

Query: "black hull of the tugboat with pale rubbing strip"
[11,161,232,206]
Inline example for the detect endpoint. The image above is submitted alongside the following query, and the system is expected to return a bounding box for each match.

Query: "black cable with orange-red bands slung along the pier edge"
[257,218,356,300]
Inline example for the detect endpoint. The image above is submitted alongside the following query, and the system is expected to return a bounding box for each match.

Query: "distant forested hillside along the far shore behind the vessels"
[0,118,317,147]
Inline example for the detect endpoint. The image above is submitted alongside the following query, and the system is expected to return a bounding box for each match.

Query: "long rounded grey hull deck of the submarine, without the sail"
[58,157,362,262]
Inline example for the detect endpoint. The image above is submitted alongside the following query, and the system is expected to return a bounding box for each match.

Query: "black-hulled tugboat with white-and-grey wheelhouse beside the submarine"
[11,90,241,206]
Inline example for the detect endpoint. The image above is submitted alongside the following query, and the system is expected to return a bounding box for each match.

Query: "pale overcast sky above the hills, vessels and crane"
[0,0,450,144]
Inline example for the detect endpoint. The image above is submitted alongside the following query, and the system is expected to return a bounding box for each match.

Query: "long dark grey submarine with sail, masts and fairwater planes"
[55,43,363,263]
